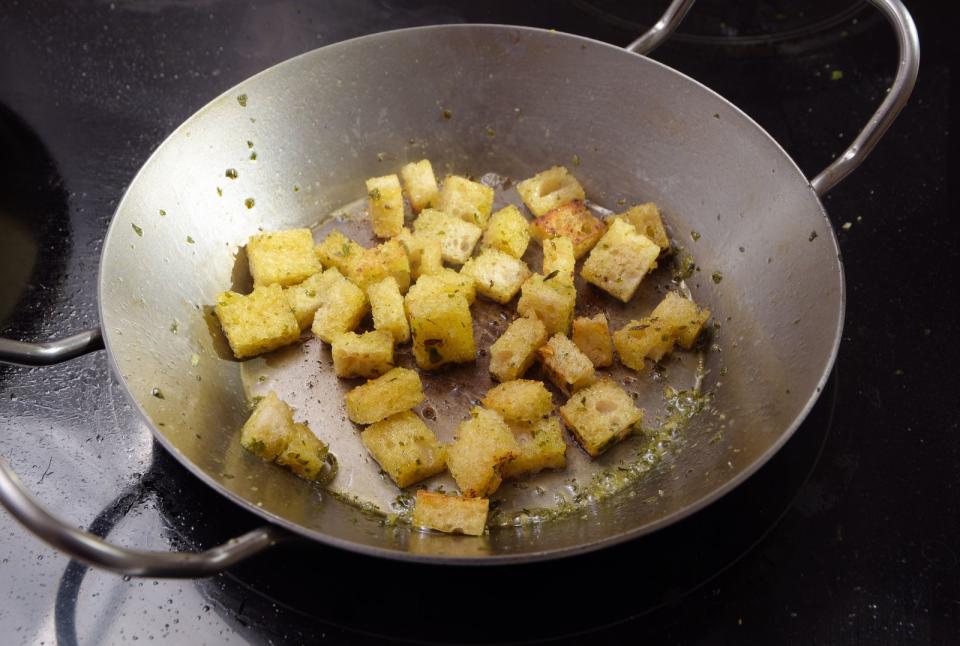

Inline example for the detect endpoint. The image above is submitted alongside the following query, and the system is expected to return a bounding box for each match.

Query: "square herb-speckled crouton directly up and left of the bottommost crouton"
[360,411,446,487]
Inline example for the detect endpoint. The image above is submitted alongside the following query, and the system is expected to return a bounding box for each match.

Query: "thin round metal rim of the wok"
[97,23,847,566]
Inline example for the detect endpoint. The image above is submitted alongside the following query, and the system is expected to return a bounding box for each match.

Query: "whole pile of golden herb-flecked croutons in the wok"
[216,160,710,535]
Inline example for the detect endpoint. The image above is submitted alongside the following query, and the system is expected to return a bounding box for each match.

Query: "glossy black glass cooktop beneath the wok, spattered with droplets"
[0,0,960,644]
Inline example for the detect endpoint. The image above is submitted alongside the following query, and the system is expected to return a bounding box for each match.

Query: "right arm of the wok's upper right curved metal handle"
[810,0,920,197]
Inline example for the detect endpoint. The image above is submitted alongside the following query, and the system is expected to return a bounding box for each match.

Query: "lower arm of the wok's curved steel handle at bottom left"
[0,457,289,578]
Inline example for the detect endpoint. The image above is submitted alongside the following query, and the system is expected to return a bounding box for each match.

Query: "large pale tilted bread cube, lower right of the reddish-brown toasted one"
[580,220,660,303]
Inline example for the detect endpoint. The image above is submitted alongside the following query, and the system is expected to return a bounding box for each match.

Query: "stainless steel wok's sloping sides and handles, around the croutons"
[0,0,919,576]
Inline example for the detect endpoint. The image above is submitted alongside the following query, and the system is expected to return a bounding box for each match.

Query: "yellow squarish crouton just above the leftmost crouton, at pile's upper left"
[247,229,323,287]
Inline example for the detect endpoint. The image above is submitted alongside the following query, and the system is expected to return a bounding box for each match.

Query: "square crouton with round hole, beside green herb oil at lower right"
[560,379,643,457]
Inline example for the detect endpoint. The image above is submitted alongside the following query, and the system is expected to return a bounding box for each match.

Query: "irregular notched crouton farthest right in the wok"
[613,292,710,370]
